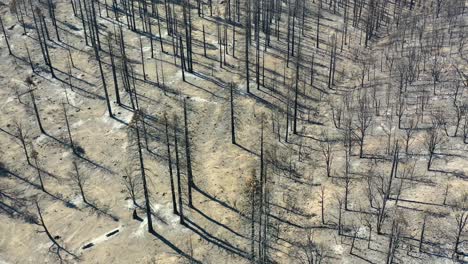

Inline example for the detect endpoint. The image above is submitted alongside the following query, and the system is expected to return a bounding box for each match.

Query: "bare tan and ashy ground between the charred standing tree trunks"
[0,1,468,264]
